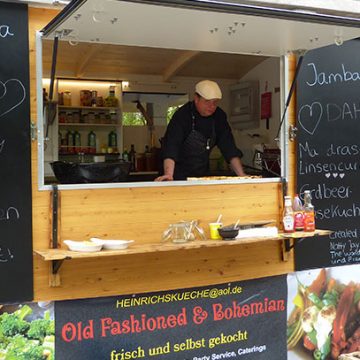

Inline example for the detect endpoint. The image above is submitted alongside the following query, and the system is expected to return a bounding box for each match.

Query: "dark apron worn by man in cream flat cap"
[174,107,216,180]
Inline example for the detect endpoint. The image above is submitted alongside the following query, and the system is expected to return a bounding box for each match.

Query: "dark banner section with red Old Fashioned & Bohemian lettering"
[55,275,287,360]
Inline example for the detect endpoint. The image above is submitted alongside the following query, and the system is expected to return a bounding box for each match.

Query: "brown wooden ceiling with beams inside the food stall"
[43,40,267,82]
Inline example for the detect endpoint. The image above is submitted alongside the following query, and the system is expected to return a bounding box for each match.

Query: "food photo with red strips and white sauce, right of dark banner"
[287,265,360,360]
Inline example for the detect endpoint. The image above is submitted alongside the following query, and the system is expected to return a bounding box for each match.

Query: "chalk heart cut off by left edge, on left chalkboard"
[0,79,26,117]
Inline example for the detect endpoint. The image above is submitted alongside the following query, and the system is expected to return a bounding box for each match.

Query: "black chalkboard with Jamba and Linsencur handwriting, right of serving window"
[295,39,360,270]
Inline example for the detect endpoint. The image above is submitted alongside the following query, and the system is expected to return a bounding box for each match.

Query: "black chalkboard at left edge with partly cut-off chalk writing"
[0,2,33,303]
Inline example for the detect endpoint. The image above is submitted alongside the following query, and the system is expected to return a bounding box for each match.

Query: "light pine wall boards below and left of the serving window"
[29,8,293,300]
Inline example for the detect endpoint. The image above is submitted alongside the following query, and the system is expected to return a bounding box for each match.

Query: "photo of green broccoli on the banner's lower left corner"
[0,302,55,360]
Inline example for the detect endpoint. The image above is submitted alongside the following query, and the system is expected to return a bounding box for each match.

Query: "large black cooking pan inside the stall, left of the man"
[51,161,131,184]
